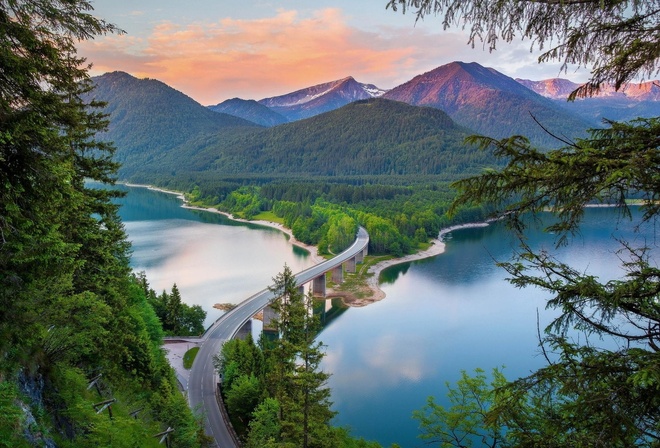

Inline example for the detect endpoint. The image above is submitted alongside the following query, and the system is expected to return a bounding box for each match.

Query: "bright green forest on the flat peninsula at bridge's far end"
[180,176,487,256]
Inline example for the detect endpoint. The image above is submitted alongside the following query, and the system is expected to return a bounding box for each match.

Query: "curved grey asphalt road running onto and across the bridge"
[188,227,369,448]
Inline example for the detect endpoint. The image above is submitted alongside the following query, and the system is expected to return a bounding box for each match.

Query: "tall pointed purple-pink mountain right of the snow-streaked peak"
[383,62,594,147]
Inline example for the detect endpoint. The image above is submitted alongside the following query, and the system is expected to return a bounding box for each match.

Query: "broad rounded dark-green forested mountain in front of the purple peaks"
[139,98,493,179]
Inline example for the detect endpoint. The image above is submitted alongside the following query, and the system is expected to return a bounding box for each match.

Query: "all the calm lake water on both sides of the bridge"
[112,188,655,447]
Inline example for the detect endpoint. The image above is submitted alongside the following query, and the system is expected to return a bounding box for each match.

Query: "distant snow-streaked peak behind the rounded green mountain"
[254,76,385,121]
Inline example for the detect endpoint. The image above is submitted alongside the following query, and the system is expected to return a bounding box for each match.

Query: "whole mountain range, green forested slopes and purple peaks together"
[90,62,660,181]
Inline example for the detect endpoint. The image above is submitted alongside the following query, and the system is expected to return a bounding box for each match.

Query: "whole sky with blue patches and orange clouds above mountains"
[78,0,588,105]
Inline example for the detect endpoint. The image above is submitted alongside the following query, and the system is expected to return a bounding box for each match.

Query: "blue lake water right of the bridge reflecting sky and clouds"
[320,209,655,447]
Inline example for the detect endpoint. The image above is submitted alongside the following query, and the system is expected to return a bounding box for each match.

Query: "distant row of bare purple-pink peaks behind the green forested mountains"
[205,62,660,146]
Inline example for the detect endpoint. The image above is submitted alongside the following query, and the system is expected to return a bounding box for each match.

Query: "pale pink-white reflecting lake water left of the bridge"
[114,186,313,326]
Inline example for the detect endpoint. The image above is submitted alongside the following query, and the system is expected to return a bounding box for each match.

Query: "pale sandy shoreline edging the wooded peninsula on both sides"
[118,182,489,307]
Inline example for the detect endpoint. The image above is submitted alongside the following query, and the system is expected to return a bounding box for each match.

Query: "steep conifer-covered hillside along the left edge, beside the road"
[0,4,206,448]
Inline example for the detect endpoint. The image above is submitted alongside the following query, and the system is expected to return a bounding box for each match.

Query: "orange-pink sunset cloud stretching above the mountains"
[79,9,466,105]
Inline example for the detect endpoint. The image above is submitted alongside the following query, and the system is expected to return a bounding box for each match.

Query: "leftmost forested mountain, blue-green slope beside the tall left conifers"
[86,72,260,178]
